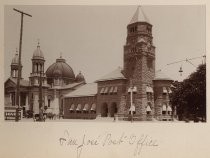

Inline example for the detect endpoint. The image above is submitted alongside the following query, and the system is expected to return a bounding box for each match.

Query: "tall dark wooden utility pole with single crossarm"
[13,8,32,122]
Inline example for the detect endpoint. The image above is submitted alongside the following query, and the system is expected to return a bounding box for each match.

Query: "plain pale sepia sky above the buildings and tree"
[4,5,206,83]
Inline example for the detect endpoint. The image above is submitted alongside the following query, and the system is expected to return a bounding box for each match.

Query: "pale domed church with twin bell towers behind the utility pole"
[5,43,85,115]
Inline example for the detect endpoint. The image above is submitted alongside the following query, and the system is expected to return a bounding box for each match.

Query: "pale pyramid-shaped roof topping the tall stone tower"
[129,6,149,24]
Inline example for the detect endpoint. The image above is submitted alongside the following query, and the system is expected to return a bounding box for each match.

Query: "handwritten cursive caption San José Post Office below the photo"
[59,130,159,158]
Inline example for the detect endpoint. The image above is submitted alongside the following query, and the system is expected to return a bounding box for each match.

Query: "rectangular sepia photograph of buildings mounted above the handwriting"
[4,5,207,123]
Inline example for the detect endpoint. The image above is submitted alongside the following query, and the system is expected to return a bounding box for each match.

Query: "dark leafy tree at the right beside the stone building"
[170,64,206,122]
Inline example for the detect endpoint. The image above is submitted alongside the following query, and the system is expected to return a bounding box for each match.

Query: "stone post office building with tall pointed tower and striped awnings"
[64,7,172,120]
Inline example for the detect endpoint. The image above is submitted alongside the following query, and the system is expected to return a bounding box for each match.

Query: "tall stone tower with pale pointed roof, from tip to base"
[124,6,155,120]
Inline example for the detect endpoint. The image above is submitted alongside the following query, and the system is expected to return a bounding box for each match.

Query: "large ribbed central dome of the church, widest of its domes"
[46,57,75,79]
